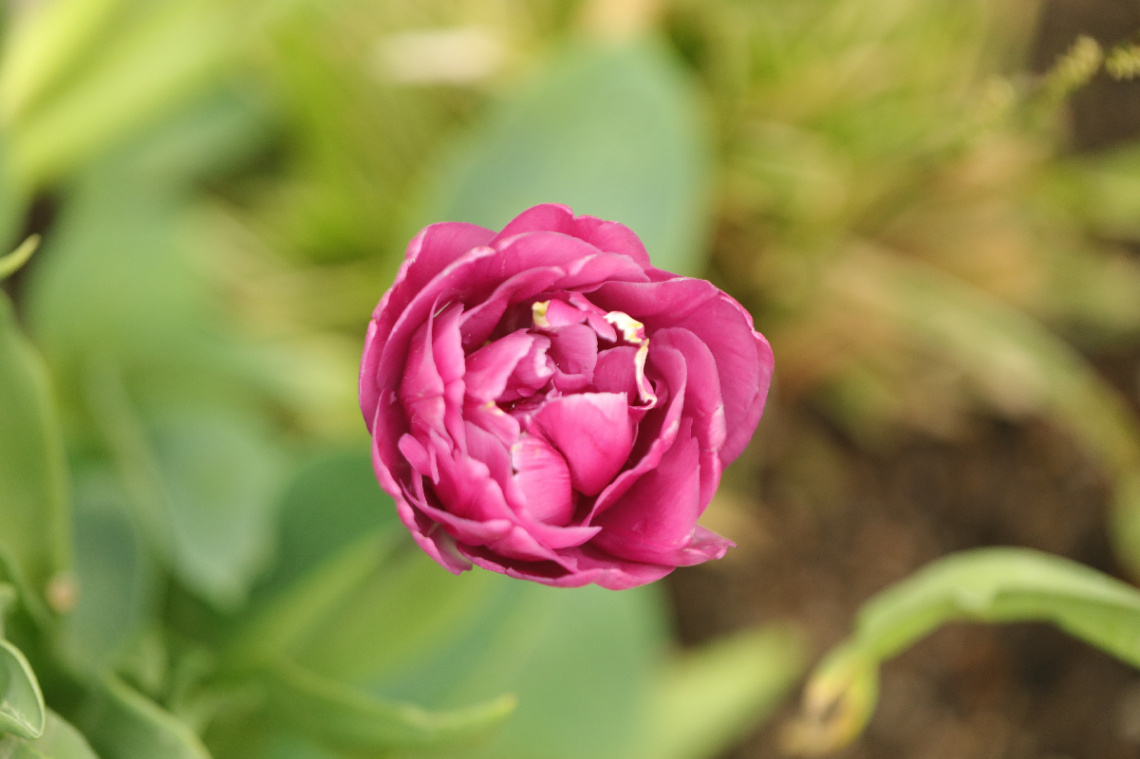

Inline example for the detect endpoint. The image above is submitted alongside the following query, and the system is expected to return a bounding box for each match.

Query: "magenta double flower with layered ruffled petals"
[360,205,772,589]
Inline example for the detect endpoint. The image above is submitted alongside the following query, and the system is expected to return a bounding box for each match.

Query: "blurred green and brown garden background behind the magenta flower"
[0,0,1140,759]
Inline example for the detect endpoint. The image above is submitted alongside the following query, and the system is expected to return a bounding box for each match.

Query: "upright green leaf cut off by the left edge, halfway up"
[0,294,71,601]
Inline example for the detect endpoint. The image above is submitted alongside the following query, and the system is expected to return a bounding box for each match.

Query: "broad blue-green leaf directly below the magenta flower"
[387,572,666,759]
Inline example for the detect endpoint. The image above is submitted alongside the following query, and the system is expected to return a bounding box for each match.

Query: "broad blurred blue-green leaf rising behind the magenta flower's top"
[424,40,710,275]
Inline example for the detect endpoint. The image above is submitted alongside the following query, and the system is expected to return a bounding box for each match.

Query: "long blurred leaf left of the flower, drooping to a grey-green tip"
[29,154,287,607]
